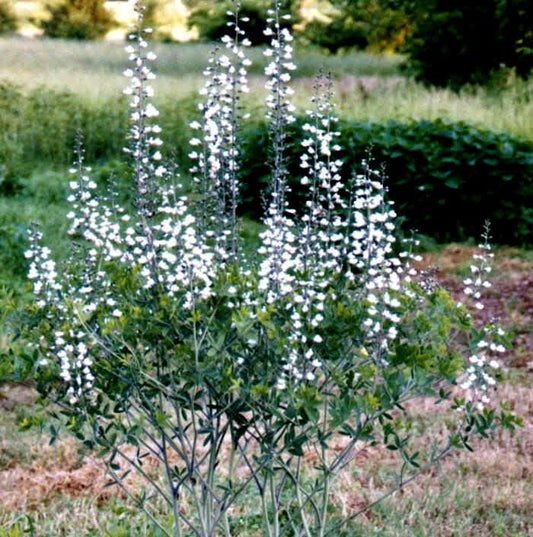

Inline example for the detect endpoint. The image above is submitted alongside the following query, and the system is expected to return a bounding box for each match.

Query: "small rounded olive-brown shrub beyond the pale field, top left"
[41,0,114,39]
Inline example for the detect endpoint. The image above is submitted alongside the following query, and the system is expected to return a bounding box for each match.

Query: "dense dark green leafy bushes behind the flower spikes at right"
[238,120,533,244]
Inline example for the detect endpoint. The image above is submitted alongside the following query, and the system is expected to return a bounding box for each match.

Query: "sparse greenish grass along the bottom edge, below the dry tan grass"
[0,479,530,537]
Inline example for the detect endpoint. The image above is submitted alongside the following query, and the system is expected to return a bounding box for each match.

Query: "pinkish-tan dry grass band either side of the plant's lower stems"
[0,372,533,514]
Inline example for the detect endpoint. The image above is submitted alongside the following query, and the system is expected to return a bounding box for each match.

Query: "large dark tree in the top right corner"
[407,0,533,89]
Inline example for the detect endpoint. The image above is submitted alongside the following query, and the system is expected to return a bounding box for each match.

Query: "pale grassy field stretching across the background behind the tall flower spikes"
[0,38,533,140]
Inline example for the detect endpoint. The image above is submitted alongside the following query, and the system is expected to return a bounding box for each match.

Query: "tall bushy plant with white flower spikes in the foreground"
[27,1,514,537]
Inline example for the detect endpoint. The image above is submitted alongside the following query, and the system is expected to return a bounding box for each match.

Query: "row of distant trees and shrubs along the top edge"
[5,0,533,90]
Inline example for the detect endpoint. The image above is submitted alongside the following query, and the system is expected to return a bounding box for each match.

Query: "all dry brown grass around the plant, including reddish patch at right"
[0,246,533,537]
